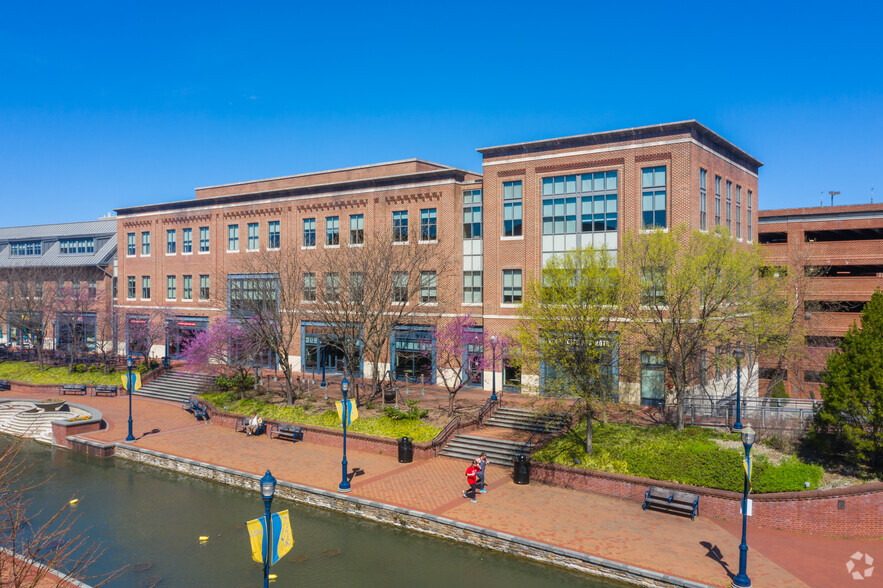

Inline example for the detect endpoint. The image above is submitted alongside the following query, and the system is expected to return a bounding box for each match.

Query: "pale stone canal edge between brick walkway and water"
[109,439,711,588]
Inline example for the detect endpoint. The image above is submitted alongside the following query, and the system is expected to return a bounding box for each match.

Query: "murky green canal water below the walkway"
[6,435,619,588]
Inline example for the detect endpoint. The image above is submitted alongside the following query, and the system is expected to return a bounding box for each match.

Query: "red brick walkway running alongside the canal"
[7,392,883,586]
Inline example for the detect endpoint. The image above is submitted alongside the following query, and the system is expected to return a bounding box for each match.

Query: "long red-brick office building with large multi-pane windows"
[117,121,762,401]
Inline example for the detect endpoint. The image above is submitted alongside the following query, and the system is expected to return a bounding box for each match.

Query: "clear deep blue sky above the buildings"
[0,1,883,226]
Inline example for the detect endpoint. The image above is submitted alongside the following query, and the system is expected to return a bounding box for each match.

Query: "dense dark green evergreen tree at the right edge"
[814,289,883,469]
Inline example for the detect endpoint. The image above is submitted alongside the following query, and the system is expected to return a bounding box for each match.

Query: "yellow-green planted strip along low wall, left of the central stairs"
[201,392,440,443]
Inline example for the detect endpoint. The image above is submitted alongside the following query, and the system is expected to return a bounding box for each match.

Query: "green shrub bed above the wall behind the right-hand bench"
[533,422,824,493]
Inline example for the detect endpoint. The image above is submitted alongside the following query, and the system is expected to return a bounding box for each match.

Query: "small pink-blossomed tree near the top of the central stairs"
[427,315,485,415]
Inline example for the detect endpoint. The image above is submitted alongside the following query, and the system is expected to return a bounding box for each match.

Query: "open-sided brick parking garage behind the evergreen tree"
[758,204,883,398]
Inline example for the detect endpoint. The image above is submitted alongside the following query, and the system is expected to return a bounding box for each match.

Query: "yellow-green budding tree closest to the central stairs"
[516,249,619,455]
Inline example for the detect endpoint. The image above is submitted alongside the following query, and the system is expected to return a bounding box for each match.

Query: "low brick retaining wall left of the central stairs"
[201,397,478,460]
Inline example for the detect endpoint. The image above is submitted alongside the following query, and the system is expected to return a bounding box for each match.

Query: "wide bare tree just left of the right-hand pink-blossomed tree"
[310,227,454,402]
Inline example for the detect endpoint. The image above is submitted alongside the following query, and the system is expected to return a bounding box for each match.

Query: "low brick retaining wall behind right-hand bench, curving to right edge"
[531,462,883,539]
